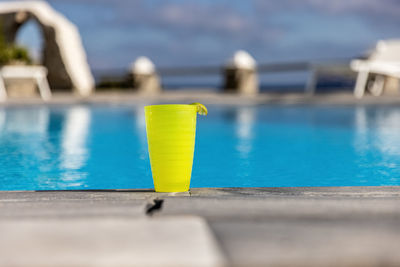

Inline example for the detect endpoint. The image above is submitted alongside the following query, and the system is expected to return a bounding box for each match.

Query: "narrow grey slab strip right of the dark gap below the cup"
[158,198,400,222]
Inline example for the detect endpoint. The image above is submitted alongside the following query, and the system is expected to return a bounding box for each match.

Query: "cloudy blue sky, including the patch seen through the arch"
[14,0,400,70]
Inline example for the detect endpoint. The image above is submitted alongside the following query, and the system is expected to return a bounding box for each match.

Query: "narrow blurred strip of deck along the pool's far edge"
[0,89,400,106]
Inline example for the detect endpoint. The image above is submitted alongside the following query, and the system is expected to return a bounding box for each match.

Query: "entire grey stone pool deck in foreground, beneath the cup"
[0,186,400,266]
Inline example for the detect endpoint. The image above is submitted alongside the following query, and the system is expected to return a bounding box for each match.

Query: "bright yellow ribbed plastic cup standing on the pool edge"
[144,105,197,192]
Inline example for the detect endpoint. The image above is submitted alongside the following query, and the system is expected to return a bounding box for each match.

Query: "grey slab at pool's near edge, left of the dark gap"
[0,189,190,219]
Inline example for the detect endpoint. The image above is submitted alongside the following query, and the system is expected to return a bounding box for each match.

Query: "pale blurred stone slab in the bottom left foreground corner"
[0,216,225,267]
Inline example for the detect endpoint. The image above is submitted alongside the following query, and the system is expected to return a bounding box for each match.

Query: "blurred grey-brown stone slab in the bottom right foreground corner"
[211,219,400,266]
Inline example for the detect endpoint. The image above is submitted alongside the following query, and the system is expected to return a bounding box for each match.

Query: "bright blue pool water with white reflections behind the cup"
[0,105,400,190]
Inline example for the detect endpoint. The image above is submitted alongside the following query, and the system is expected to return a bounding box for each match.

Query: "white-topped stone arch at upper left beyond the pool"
[0,1,94,96]
